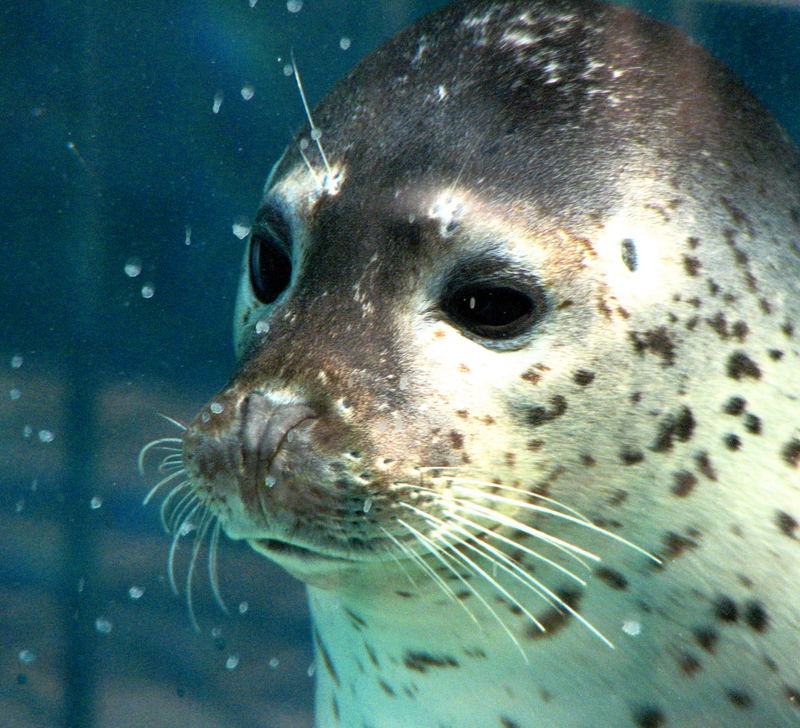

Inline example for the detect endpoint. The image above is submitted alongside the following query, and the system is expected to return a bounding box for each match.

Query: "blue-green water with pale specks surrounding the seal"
[0,0,800,728]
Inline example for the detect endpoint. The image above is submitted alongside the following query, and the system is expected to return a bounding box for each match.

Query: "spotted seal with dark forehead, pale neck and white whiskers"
[177,0,800,728]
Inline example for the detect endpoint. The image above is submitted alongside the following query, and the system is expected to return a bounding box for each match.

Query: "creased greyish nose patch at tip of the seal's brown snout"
[240,392,317,486]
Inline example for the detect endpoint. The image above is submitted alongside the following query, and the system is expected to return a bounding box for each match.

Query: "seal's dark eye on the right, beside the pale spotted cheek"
[442,283,545,340]
